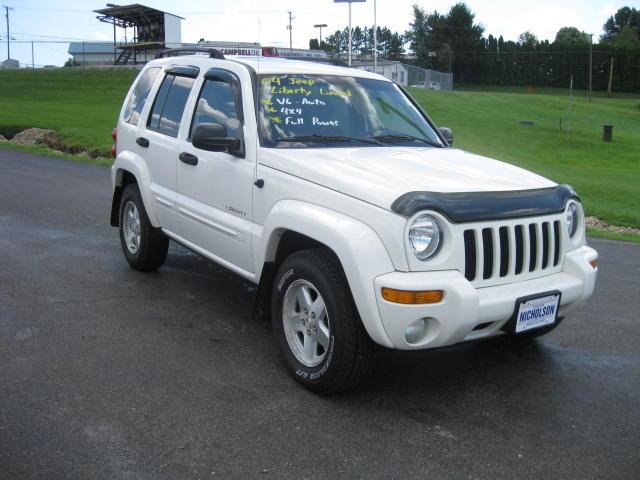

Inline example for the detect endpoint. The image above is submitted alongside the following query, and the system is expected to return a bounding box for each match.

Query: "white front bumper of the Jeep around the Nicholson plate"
[374,246,598,350]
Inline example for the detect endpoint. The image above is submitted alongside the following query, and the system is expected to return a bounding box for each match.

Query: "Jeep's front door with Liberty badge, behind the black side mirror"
[177,66,256,276]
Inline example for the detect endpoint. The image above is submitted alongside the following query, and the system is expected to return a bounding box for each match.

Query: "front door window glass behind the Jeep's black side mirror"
[189,80,241,138]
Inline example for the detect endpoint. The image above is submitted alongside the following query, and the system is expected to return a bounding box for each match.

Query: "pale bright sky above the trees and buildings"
[0,0,640,65]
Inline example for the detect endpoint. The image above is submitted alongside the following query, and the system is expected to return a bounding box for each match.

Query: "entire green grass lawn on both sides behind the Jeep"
[0,69,640,232]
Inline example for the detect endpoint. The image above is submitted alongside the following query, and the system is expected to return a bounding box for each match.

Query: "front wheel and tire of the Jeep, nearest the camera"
[271,248,375,394]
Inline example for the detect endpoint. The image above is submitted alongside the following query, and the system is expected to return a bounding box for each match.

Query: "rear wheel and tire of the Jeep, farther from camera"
[118,183,169,272]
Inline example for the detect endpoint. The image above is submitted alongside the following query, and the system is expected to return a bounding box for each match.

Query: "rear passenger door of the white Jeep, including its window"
[136,66,199,232]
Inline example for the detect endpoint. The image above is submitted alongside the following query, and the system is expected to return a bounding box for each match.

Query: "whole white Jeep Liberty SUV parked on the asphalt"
[111,50,598,393]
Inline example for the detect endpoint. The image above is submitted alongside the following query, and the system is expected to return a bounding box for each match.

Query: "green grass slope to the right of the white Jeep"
[411,88,640,228]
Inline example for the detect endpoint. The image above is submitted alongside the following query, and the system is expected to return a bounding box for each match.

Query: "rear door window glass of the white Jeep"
[147,75,195,137]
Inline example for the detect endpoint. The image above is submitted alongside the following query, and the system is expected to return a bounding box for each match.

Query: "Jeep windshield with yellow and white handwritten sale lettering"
[258,74,442,148]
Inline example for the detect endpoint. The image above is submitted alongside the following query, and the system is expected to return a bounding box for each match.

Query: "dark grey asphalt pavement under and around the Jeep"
[0,149,640,480]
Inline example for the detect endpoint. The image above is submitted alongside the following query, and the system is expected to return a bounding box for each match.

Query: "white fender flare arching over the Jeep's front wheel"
[254,200,395,347]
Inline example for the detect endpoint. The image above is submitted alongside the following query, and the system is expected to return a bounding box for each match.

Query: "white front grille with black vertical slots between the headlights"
[464,220,562,282]
